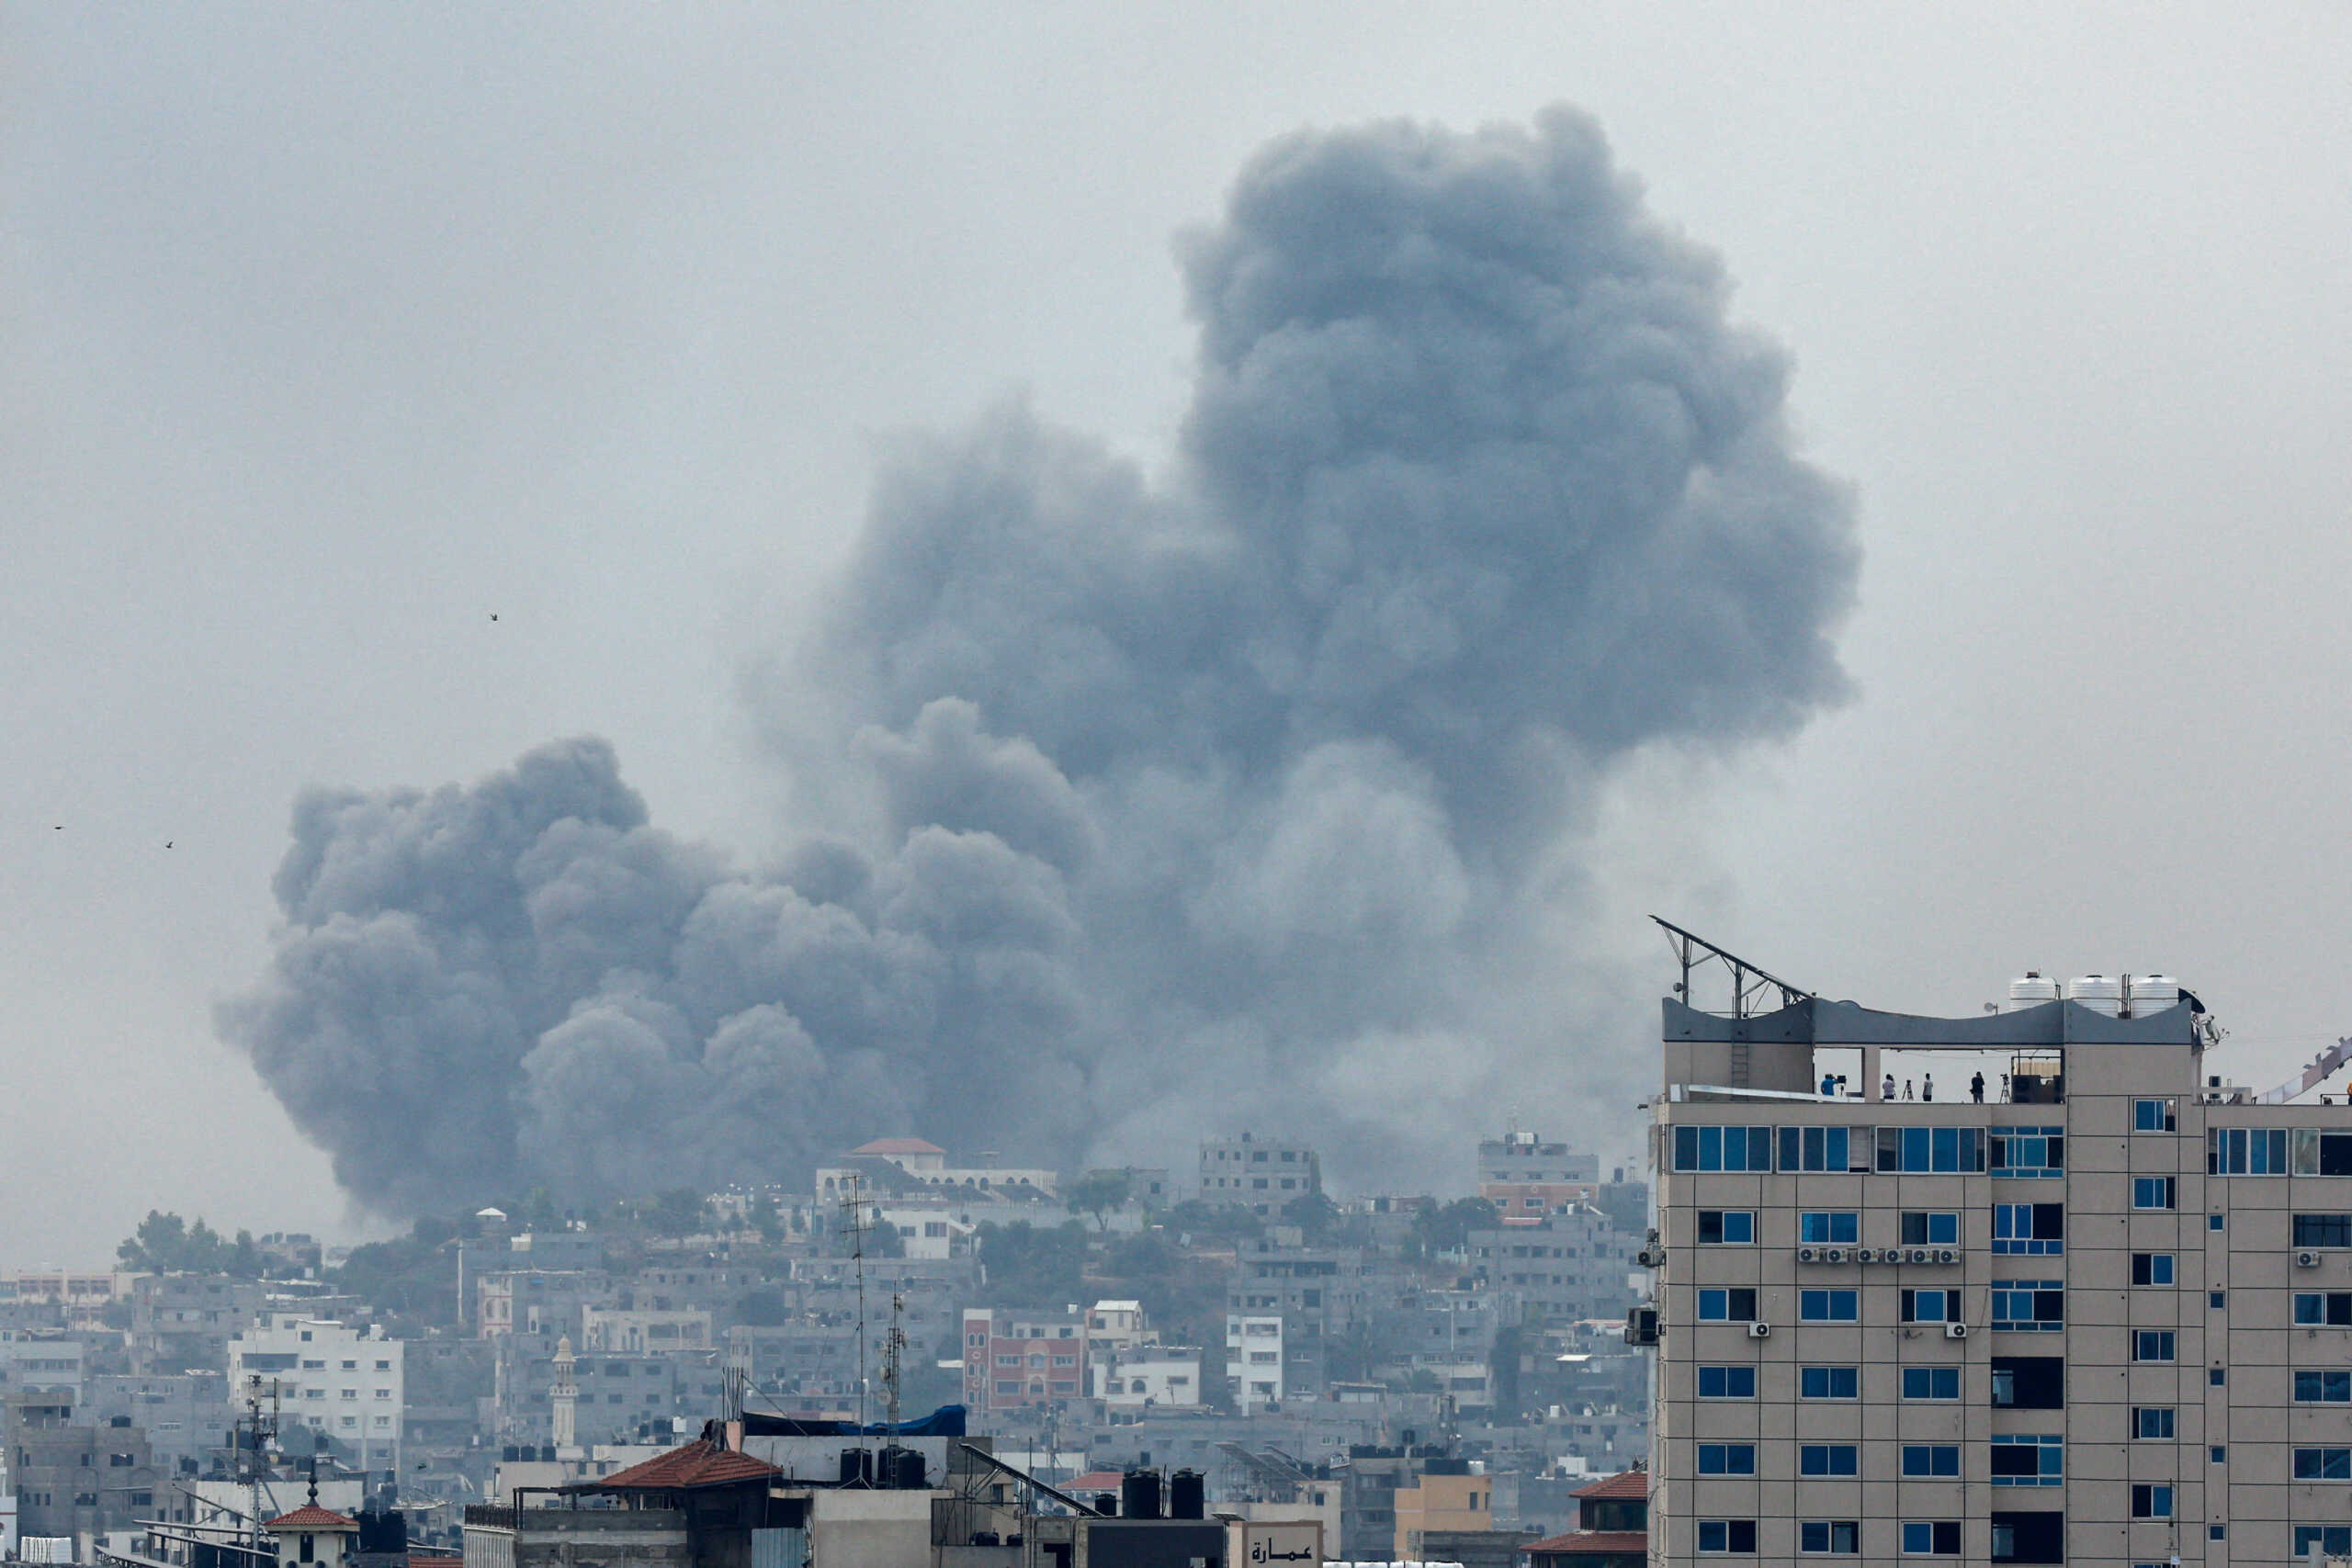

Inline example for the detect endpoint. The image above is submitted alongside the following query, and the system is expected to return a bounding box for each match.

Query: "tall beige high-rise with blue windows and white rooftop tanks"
[1628,978,2352,1568]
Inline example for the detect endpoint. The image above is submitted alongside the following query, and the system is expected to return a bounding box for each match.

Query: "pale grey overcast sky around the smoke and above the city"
[0,5,2352,1265]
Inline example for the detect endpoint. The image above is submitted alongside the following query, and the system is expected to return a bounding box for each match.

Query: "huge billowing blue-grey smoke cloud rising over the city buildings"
[223,110,1856,1213]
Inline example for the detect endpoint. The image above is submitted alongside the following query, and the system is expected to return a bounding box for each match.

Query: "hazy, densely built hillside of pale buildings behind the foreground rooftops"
[0,1131,1649,1565]
